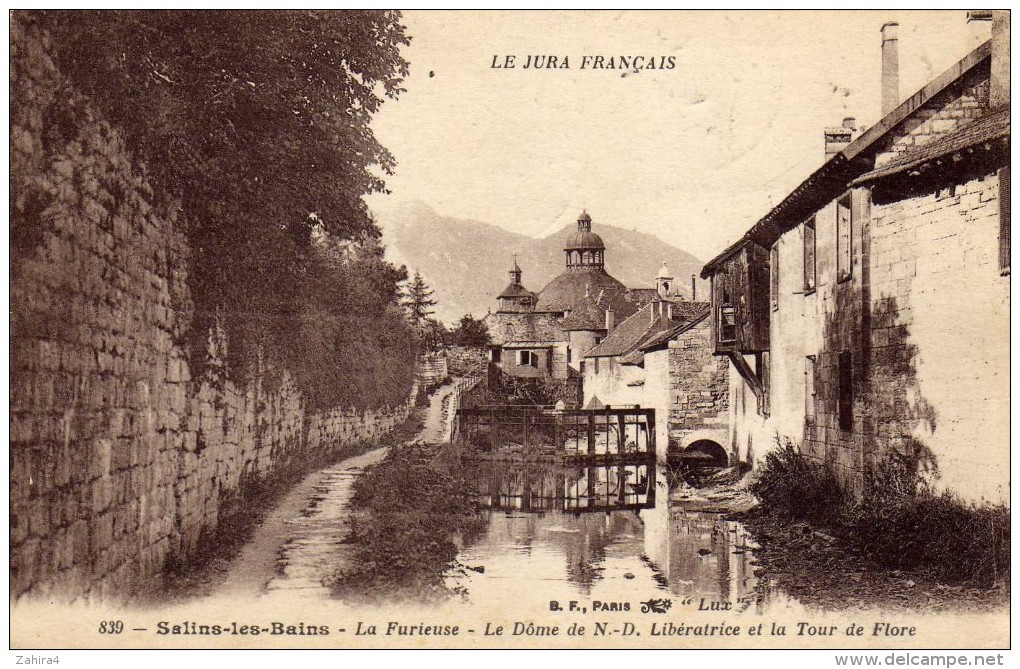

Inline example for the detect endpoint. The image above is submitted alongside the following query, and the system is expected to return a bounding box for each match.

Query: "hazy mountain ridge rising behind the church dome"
[375,202,708,323]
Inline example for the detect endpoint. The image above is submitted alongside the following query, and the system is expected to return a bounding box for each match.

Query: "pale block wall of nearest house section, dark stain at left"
[868,172,1010,502]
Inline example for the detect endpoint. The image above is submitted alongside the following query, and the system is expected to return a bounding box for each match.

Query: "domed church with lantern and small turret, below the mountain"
[485,212,655,379]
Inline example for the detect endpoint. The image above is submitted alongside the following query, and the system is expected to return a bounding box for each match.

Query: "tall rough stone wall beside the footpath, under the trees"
[9,16,413,601]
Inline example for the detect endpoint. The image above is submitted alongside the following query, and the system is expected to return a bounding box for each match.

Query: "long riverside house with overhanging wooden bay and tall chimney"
[703,12,1010,502]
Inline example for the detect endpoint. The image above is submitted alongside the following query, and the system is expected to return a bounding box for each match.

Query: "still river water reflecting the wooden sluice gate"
[451,462,758,610]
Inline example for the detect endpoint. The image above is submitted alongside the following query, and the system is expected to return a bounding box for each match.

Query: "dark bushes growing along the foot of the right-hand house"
[751,443,1010,587]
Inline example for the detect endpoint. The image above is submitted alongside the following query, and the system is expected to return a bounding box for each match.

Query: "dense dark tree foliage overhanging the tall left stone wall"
[28,10,418,406]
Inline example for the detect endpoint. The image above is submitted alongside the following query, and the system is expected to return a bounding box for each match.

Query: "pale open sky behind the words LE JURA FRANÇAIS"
[368,10,990,260]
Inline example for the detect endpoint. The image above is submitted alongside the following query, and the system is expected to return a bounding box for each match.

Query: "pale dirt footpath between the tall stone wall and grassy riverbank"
[209,385,455,599]
